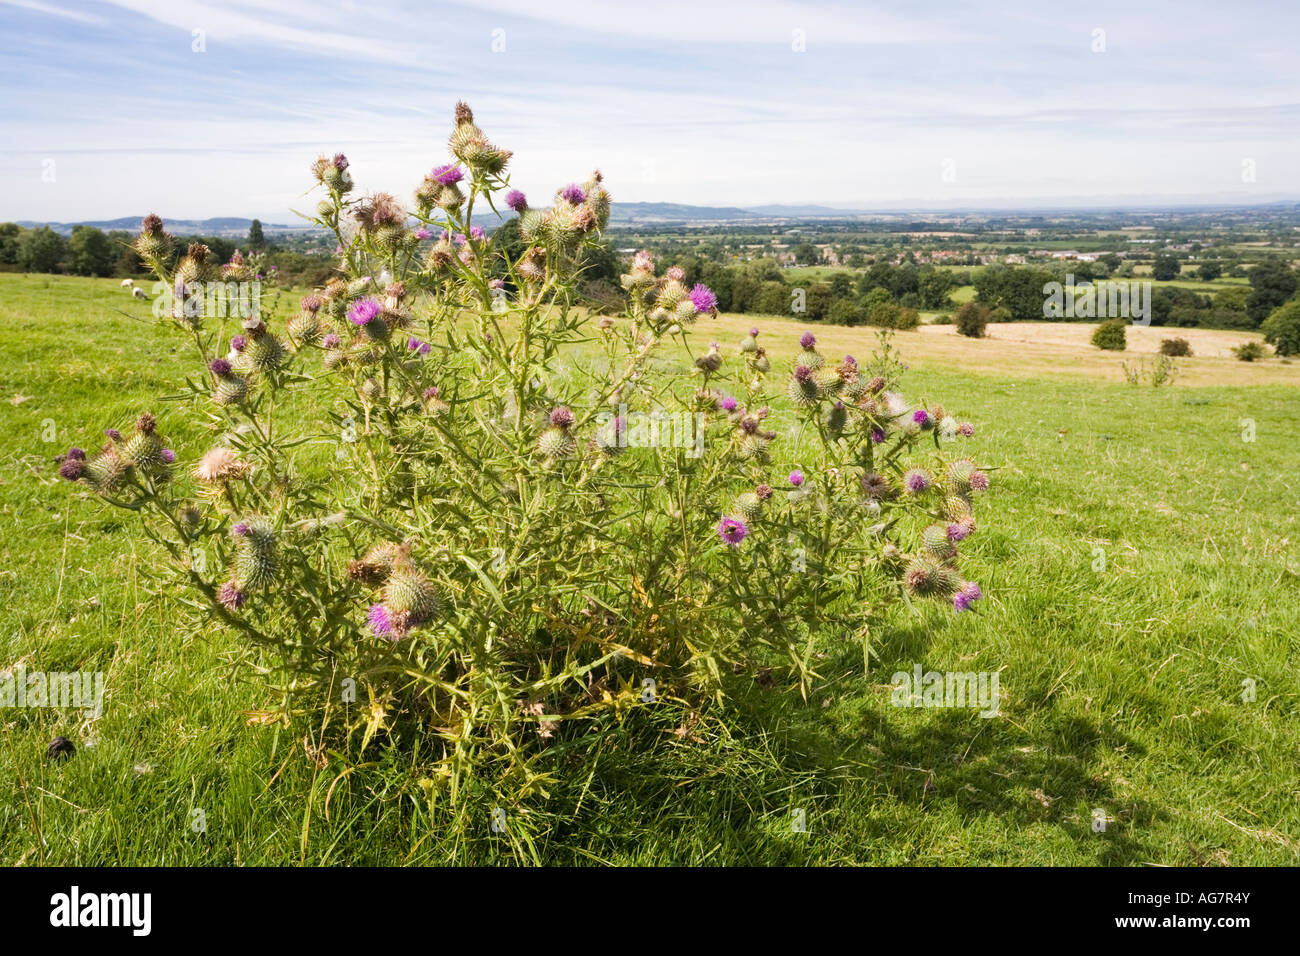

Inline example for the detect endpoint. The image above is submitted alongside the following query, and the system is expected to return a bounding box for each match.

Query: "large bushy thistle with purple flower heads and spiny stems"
[60,104,989,827]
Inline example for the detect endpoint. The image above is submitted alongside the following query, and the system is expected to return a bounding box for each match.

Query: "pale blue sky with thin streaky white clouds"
[0,0,1300,222]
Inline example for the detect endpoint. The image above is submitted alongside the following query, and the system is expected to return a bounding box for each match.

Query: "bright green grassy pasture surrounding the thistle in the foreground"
[0,276,1300,865]
